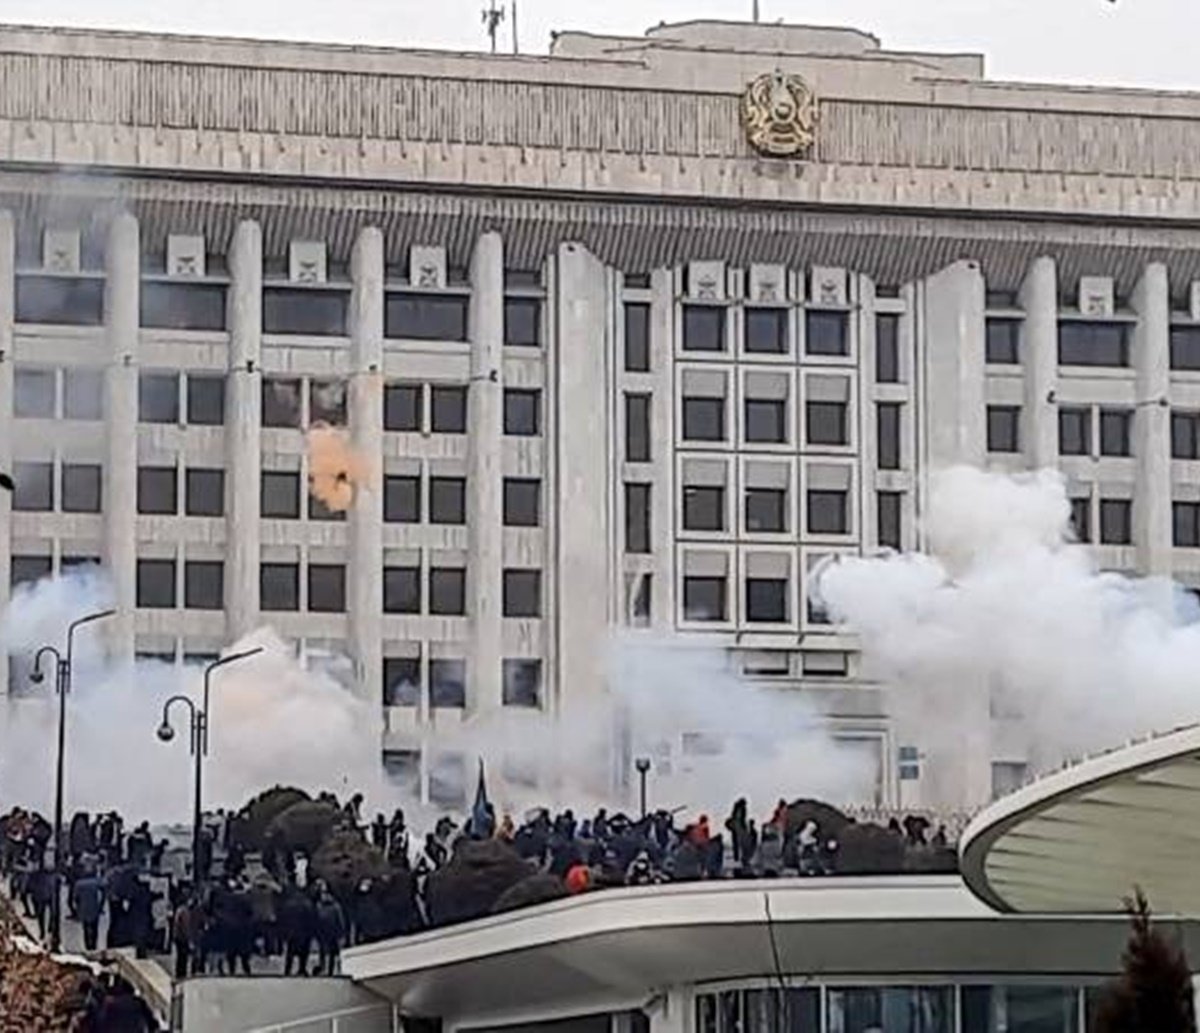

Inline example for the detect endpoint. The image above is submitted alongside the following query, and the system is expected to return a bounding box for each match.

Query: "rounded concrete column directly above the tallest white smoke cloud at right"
[1018,257,1058,470]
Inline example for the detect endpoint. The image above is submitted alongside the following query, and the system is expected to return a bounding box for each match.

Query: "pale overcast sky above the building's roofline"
[0,0,1200,90]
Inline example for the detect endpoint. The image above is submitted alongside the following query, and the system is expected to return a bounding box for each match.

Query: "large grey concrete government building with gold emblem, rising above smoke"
[0,12,1200,811]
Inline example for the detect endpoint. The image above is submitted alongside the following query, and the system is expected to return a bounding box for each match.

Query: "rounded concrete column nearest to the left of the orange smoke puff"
[226,222,263,642]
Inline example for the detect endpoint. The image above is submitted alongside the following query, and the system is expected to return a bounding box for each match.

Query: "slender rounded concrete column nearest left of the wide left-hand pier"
[467,233,504,711]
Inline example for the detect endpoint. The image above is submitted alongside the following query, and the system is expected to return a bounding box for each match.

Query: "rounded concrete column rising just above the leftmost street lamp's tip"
[104,212,142,660]
